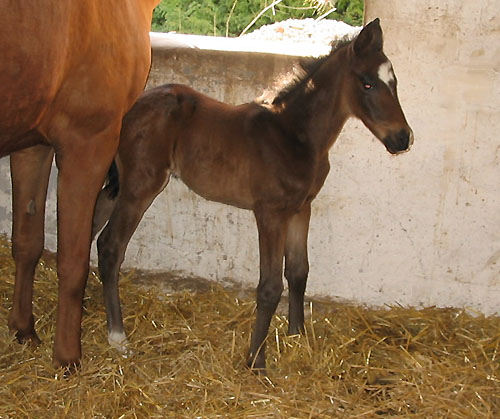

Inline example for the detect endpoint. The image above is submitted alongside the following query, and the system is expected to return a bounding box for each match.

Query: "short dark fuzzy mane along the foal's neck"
[272,36,354,109]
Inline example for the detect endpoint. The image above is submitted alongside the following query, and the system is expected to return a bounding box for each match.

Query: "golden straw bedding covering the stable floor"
[0,239,500,418]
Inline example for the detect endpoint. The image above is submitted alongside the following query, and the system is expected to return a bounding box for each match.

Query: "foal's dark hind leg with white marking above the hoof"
[97,166,170,353]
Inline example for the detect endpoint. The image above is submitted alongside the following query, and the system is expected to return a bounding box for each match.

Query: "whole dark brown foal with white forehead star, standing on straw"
[93,19,413,370]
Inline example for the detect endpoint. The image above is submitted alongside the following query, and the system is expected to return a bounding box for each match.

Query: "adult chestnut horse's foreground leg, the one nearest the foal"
[53,124,120,367]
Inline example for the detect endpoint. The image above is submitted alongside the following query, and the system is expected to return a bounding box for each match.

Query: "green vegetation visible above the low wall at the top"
[152,0,364,36]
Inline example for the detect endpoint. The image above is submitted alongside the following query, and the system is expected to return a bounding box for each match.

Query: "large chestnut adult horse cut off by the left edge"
[0,0,158,366]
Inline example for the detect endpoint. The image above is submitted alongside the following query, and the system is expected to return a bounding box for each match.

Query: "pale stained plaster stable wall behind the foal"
[0,0,500,313]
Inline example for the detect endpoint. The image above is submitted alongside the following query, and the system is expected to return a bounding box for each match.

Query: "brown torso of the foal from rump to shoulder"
[119,84,311,209]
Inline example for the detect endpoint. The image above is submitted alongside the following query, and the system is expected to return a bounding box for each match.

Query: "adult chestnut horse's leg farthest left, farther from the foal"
[9,145,54,345]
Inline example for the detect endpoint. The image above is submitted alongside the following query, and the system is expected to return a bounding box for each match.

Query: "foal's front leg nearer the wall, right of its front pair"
[285,204,311,335]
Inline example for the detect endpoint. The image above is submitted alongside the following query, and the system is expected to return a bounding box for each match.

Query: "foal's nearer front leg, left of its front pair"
[247,208,287,370]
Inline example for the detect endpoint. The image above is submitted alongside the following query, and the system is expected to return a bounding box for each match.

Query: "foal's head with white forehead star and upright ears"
[344,19,413,154]
